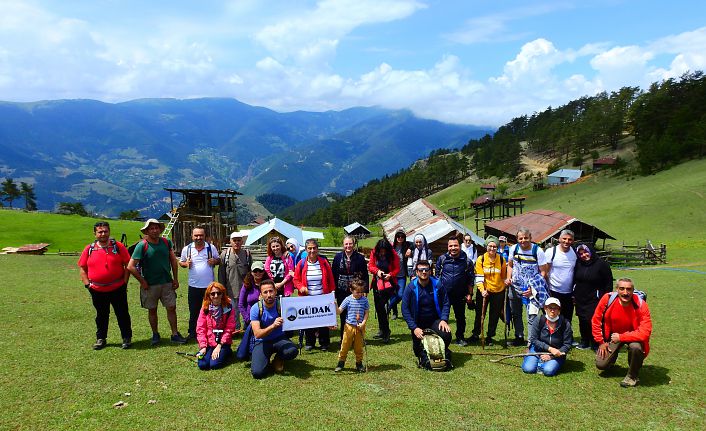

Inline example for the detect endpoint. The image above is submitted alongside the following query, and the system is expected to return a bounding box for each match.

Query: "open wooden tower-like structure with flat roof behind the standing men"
[162,189,242,250]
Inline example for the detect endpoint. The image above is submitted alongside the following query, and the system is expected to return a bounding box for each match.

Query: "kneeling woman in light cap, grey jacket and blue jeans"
[522,298,574,377]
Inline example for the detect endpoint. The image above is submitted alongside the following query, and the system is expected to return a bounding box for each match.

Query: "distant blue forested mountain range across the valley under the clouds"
[0,98,492,216]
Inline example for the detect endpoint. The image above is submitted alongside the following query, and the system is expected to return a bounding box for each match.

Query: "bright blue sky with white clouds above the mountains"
[0,0,706,127]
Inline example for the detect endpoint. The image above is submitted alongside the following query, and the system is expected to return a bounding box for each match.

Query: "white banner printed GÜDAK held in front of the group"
[281,293,338,331]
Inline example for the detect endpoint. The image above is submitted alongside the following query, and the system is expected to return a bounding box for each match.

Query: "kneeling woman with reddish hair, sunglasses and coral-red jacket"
[196,282,235,370]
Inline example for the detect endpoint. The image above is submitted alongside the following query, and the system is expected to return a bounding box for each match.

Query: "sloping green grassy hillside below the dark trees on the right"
[428,160,706,264]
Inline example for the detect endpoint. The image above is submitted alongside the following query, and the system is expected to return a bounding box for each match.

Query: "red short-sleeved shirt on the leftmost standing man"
[78,240,130,292]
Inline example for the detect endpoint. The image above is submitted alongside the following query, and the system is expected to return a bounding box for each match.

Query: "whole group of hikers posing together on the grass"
[78,219,652,386]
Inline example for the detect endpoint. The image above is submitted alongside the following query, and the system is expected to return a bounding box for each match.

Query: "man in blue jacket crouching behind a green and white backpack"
[402,260,451,363]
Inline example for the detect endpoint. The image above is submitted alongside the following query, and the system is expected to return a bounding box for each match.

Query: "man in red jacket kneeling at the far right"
[592,278,652,388]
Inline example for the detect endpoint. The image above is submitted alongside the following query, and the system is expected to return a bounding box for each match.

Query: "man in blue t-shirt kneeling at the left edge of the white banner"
[250,280,299,379]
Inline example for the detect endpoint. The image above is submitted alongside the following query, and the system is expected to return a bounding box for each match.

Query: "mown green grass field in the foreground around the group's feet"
[0,255,706,430]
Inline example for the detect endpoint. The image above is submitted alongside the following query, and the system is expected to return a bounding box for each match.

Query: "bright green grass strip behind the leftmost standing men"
[0,210,142,252]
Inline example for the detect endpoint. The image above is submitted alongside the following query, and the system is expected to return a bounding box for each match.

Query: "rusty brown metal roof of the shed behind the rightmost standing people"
[485,210,615,248]
